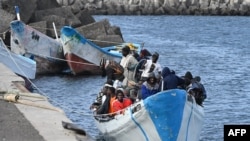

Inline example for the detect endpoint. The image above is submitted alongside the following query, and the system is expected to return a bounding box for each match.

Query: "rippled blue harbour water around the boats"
[33,16,250,141]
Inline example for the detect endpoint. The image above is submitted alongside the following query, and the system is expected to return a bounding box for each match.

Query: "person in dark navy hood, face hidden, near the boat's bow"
[160,67,185,90]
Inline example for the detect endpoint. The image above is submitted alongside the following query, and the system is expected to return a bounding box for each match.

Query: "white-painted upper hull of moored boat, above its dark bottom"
[10,20,63,61]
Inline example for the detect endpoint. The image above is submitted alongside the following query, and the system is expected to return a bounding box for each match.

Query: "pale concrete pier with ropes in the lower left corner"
[0,63,93,141]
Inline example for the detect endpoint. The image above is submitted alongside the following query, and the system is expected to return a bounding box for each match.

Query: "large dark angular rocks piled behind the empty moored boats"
[0,0,124,47]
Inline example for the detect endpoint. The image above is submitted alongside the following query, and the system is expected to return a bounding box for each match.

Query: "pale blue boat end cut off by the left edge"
[0,38,36,79]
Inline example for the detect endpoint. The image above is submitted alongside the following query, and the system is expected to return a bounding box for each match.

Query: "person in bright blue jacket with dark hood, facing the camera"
[141,73,159,99]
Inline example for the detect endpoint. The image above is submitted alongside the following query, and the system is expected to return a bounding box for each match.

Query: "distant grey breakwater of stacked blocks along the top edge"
[56,0,250,16]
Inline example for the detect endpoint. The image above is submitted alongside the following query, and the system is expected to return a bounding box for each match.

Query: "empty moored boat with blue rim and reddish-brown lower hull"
[60,26,141,75]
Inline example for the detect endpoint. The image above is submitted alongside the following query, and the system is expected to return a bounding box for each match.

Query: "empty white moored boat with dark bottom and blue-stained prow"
[10,20,64,74]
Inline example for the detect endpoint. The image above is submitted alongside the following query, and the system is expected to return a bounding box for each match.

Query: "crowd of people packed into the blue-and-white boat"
[91,46,207,115]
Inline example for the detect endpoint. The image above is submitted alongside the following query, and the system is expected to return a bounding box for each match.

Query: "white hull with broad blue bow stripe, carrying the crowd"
[94,89,204,141]
